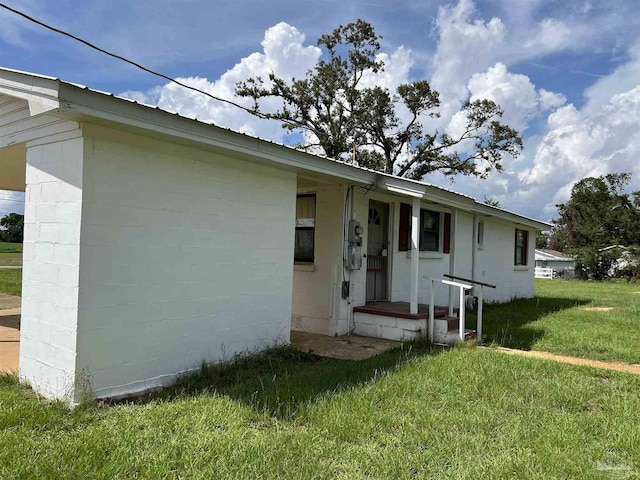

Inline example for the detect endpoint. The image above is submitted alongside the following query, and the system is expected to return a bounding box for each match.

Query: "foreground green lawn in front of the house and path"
[0,346,640,479]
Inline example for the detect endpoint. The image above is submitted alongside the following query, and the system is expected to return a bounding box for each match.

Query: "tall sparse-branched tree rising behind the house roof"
[236,20,523,179]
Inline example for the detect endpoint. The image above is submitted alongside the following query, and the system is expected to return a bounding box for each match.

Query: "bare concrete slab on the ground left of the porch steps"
[291,331,401,360]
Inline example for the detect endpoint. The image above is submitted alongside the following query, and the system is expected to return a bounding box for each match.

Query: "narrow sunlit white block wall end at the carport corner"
[19,138,84,400]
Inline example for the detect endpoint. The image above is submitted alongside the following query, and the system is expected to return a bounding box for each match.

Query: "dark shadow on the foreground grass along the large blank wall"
[111,343,441,419]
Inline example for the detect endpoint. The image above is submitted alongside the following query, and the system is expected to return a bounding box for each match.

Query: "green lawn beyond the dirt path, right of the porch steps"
[480,279,640,363]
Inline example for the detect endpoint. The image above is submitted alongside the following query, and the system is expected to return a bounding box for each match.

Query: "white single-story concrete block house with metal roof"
[0,69,549,402]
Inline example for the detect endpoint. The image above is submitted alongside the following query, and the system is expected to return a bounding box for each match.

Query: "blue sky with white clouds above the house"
[0,0,640,221]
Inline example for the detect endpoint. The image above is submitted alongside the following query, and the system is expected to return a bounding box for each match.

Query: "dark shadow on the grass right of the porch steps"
[476,297,590,350]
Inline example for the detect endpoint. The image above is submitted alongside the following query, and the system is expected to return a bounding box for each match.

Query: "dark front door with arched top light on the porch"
[367,200,389,302]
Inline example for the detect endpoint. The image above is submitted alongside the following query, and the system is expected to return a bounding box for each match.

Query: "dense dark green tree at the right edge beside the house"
[550,173,640,279]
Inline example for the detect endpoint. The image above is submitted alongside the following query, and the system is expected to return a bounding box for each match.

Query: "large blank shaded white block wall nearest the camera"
[77,130,296,396]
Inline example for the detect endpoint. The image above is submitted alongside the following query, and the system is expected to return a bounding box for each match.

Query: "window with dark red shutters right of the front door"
[398,203,451,253]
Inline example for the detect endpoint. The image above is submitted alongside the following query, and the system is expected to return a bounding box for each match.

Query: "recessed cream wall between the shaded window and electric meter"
[291,185,346,335]
